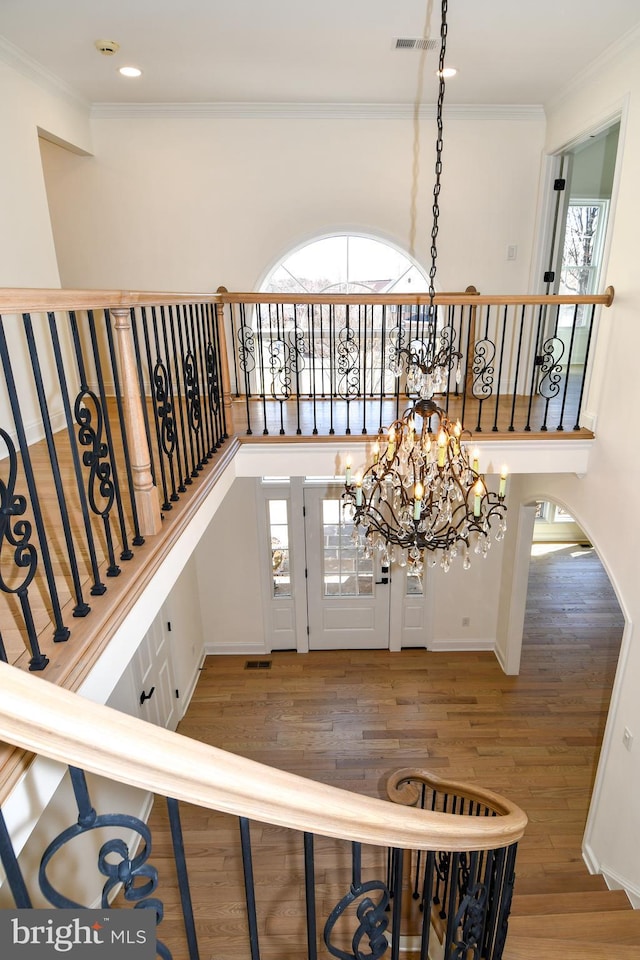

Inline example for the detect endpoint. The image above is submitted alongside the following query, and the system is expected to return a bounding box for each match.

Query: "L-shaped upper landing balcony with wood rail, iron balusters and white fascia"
[0,288,613,689]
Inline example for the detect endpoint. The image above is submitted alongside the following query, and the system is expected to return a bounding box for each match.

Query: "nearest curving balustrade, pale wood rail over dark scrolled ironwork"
[0,664,526,960]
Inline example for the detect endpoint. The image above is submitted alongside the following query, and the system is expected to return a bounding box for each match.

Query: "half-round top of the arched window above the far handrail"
[261,234,429,293]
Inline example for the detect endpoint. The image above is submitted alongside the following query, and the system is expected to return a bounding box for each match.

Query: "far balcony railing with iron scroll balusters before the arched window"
[222,287,613,436]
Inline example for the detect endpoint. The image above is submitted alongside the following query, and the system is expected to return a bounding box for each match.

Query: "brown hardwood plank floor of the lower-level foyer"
[142,547,628,960]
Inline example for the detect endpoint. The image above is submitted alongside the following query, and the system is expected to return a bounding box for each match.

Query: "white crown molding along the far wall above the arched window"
[91,103,545,121]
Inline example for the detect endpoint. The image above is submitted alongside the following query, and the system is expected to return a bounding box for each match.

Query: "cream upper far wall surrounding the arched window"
[37,114,544,293]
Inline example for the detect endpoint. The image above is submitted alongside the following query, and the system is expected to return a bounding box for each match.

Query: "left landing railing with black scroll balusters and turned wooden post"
[0,290,228,670]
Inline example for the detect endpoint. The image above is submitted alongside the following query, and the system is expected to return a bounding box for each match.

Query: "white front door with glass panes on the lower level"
[304,485,391,650]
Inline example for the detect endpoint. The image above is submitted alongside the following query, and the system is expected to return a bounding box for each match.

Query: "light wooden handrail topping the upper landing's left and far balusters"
[0,286,614,314]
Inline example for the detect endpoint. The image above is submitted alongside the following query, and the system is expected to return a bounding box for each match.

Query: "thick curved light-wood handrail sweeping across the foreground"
[0,663,527,851]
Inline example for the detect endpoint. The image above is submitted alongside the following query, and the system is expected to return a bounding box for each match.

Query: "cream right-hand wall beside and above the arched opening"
[536,34,640,895]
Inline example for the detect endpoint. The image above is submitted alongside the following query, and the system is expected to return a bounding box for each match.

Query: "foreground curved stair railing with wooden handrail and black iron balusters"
[0,663,526,960]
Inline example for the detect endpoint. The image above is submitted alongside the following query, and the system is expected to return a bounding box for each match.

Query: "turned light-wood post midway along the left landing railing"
[110,307,162,537]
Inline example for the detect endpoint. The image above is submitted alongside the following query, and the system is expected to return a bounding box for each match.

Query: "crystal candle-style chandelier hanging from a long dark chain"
[342,0,507,576]
